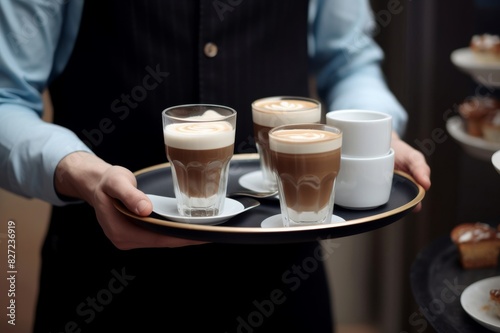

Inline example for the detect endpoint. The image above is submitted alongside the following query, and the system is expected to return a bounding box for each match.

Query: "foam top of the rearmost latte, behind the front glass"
[252,99,321,126]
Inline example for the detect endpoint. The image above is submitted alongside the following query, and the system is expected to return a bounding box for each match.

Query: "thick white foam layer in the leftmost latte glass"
[163,110,235,150]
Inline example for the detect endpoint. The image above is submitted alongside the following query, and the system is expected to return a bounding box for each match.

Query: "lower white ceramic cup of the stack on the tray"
[335,148,394,209]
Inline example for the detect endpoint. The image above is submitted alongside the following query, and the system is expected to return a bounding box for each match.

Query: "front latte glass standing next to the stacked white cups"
[269,124,342,227]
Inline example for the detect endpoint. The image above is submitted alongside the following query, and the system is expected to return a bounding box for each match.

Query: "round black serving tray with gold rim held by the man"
[115,154,425,244]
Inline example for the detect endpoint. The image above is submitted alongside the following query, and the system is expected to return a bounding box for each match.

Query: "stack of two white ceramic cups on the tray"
[326,109,394,209]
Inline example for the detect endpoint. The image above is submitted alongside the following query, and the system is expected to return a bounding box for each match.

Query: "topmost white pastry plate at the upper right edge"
[450,47,500,87]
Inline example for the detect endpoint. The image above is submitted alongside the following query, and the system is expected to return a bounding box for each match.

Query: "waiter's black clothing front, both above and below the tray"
[35,0,332,333]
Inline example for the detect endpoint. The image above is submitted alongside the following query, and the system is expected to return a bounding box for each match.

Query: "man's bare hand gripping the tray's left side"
[55,152,203,250]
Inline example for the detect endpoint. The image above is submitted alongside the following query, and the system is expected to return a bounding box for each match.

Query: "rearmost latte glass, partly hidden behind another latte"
[252,96,321,190]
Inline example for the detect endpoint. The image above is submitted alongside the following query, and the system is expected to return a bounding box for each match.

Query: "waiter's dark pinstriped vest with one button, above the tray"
[51,0,308,170]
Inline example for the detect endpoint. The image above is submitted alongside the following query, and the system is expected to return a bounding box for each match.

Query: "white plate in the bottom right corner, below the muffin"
[460,276,500,332]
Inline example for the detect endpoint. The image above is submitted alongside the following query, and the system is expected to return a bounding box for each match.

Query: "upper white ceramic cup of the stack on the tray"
[326,109,392,157]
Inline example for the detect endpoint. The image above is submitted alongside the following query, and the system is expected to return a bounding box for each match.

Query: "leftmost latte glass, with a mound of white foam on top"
[162,104,236,216]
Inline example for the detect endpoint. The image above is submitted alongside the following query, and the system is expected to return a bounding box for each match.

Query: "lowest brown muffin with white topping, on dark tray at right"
[451,222,500,269]
